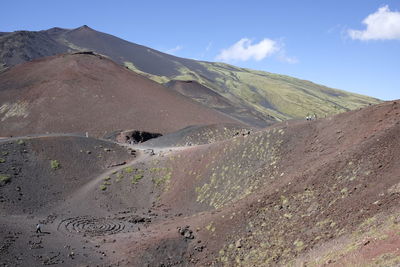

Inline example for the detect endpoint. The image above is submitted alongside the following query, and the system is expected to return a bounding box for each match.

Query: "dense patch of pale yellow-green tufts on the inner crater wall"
[195,128,284,209]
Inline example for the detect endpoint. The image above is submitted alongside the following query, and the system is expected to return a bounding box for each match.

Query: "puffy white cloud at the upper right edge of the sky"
[348,5,400,41]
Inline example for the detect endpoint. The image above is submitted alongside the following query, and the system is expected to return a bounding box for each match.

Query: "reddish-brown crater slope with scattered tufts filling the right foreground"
[104,102,400,266]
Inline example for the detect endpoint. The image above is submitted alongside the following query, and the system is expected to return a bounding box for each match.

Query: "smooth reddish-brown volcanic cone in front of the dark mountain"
[0,53,241,136]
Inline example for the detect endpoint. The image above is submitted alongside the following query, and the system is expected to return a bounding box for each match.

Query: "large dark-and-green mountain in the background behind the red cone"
[0,25,380,126]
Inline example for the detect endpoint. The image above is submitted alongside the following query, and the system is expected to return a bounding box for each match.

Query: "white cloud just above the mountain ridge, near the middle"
[216,38,279,61]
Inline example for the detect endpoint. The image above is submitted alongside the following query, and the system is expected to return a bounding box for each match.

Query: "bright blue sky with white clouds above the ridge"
[0,0,400,100]
